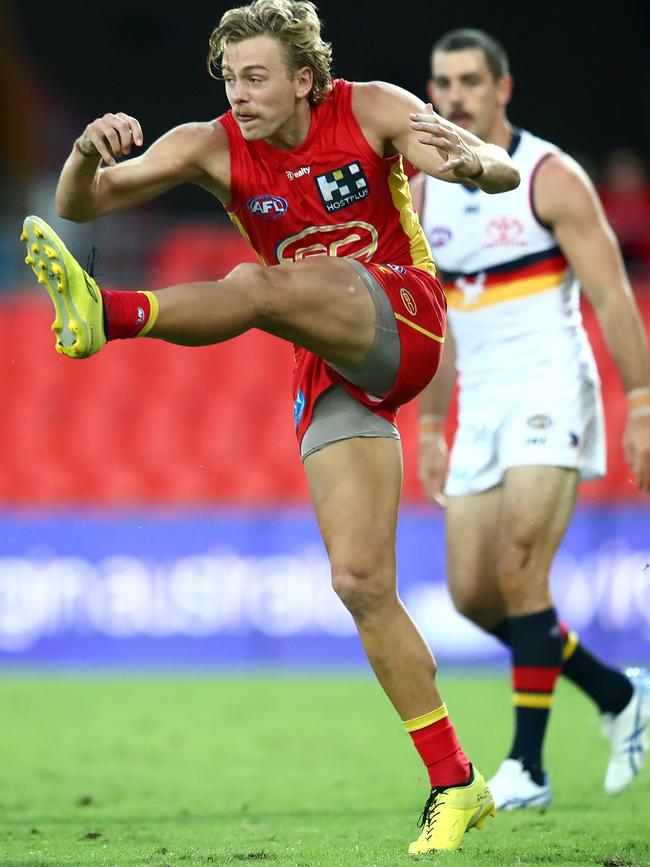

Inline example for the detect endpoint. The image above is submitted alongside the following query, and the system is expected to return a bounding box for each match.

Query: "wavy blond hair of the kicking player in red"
[208,0,332,105]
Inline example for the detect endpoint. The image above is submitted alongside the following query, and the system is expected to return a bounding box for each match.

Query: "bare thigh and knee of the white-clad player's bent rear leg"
[445,486,505,628]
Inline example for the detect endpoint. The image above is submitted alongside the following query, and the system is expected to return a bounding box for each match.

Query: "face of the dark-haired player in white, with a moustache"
[429,48,512,139]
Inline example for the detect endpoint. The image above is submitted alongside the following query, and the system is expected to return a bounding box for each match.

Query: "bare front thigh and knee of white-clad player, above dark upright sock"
[498,465,578,582]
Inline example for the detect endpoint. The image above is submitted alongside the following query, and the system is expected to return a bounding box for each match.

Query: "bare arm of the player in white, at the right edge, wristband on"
[533,154,650,492]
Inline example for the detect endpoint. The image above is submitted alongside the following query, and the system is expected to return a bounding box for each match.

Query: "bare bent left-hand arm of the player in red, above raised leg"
[56,114,230,222]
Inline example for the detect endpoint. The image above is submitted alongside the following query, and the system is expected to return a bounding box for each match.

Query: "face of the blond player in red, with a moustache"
[222,36,312,141]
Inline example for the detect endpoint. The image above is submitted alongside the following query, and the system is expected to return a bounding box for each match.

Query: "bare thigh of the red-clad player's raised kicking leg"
[253,256,376,367]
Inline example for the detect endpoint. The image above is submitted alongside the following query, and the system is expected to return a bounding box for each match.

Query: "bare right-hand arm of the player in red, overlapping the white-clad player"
[352,82,519,193]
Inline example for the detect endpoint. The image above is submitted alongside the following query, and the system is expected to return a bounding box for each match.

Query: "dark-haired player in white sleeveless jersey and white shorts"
[413,29,650,809]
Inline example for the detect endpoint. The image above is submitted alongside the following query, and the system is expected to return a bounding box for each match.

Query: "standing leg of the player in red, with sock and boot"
[305,437,494,854]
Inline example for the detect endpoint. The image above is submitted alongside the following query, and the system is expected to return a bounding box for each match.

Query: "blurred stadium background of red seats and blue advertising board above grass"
[0,0,650,668]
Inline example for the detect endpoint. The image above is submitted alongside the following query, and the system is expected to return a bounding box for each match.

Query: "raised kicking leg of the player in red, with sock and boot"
[22,217,376,367]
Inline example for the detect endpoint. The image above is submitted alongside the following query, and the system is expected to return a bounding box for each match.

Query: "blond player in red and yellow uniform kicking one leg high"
[19,0,519,854]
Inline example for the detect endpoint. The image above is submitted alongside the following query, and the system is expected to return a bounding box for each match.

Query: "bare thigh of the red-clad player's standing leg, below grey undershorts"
[305,437,402,588]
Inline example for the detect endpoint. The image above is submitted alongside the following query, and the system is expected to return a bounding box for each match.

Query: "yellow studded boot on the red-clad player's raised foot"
[20,217,106,358]
